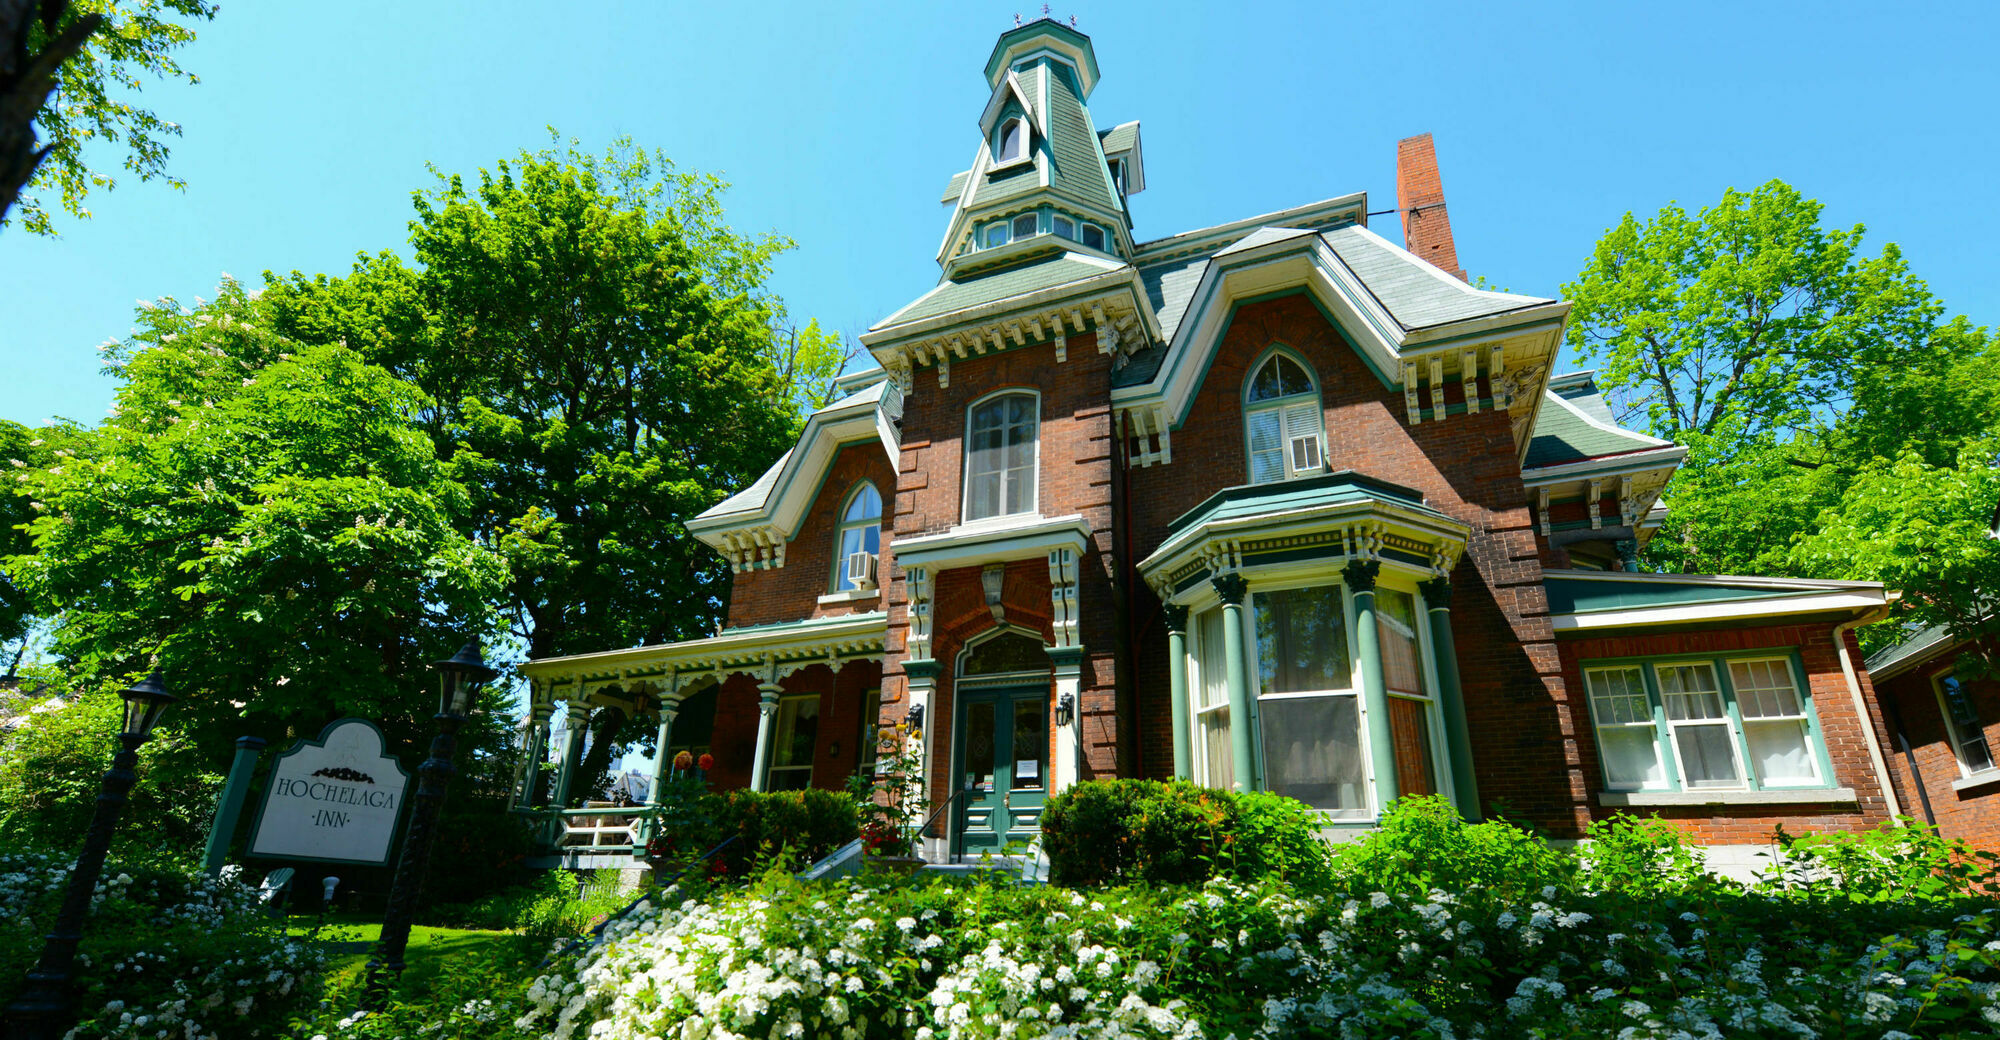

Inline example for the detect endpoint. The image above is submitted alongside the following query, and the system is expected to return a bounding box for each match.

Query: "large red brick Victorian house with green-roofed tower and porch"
[526,20,1902,860]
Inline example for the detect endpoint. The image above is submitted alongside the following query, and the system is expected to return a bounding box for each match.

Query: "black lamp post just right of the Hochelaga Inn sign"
[362,640,500,1012]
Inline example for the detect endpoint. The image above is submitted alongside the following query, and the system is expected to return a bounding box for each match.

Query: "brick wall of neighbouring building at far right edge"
[1878,656,2000,852]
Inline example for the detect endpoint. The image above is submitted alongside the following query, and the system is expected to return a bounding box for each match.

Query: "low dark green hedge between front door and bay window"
[1042,780,1330,886]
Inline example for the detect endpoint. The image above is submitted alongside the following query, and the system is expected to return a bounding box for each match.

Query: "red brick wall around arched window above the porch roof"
[730,440,896,628]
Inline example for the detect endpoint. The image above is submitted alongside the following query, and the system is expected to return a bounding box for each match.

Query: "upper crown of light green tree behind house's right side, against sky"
[1562,180,1940,444]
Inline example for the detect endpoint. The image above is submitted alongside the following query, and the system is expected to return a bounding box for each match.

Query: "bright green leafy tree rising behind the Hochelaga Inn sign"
[6,282,506,756]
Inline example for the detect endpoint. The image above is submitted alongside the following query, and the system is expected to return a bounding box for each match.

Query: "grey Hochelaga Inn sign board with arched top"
[248,718,410,866]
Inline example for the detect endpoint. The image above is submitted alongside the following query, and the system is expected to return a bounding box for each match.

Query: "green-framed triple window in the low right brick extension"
[1584,656,1830,792]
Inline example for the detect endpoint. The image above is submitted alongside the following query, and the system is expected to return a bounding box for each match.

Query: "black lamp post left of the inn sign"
[6,672,178,1040]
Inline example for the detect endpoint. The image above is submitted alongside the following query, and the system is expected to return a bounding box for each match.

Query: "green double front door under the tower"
[954,686,1048,856]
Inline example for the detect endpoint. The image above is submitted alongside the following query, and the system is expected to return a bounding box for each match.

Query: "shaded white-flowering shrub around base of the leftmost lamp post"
[0,852,326,1040]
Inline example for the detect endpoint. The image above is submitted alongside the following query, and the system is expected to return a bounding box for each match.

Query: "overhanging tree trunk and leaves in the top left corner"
[0,0,220,234]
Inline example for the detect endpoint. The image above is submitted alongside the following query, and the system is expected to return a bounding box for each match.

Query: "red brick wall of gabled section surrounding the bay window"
[1128,294,1590,834]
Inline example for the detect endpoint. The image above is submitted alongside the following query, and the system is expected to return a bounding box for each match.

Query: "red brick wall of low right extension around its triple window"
[1560,624,1908,844]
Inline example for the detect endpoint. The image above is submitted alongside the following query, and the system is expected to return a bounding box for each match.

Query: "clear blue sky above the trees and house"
[0,0,2000,422]
